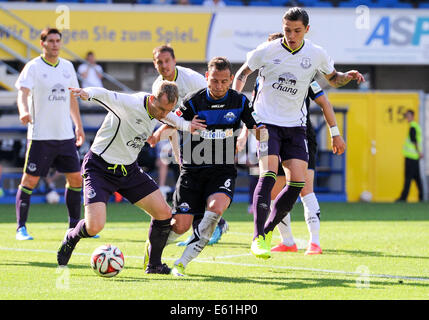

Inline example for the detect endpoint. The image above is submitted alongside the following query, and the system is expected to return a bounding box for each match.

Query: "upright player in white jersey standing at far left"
[15,28,85,240]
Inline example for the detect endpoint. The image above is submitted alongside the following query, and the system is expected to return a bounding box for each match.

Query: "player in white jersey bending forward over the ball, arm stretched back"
[57,81,205,274]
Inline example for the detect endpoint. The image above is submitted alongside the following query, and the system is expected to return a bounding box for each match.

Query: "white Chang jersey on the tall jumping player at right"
[247,39,335,127]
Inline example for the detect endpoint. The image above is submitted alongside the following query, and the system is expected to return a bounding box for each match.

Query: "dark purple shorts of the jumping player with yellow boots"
[258,124,308,162]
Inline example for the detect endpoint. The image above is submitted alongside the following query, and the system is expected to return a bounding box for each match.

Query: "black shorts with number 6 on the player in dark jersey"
[173,166,237,215]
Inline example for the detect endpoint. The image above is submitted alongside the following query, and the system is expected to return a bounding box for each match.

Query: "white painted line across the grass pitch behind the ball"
[0,247,429,282]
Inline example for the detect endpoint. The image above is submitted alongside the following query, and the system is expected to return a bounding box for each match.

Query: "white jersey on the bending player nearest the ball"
[85,87,157,165]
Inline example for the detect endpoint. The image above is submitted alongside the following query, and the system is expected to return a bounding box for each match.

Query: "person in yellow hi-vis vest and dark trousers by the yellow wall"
[396,110,423,202]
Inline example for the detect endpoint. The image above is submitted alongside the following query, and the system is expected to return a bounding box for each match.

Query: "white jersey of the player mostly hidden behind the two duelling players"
[152,66,207,108]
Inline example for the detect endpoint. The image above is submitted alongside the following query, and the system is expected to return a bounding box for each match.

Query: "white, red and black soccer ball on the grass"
[91,244,124,278]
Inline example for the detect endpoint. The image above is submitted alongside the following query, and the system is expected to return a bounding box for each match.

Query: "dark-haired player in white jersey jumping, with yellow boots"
[233,7,364,259]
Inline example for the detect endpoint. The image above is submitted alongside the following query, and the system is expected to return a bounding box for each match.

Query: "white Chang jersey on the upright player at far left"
[15,57,79,140]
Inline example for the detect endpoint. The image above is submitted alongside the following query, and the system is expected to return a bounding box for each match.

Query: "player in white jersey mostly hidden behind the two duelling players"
[152,45,228,246]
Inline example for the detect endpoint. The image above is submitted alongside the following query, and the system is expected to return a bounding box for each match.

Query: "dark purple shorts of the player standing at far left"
[24,139,80,177]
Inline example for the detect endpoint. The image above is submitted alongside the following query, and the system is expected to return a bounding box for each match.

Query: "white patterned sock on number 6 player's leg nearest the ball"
[174,211,221,267]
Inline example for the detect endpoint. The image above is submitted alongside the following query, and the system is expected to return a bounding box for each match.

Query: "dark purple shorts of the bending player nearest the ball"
[81,150,158,205]
